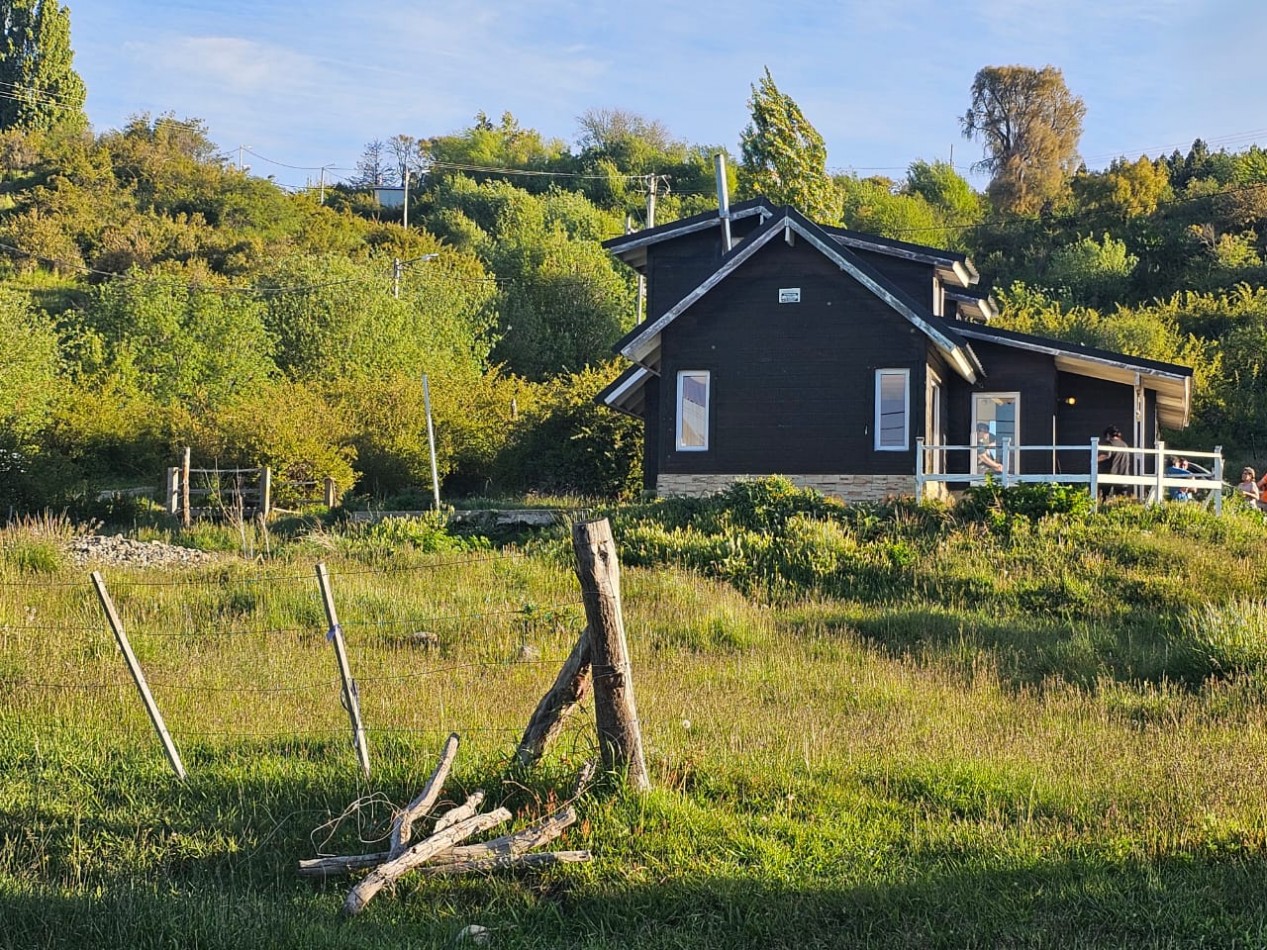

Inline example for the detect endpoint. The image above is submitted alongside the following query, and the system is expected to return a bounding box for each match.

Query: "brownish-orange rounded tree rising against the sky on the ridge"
[962,66,1087,214]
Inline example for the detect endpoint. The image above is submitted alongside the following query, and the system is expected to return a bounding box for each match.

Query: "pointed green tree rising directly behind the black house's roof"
[739,67,840,224]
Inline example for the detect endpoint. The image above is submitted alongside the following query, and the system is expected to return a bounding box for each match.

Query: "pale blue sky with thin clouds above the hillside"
[71,0,1267,195]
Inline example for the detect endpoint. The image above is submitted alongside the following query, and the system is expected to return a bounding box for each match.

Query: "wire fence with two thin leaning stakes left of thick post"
[0,552,608,774]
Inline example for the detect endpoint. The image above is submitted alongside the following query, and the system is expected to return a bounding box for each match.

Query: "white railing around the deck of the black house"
[915,438,1223,514]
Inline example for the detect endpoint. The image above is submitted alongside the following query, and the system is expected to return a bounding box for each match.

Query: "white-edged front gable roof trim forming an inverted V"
[613,208,983,383]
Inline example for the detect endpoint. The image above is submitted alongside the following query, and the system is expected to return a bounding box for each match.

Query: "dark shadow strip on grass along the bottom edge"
[7,852,1267,950]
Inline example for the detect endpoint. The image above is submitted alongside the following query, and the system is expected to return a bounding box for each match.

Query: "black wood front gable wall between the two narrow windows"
[658,239,926,475]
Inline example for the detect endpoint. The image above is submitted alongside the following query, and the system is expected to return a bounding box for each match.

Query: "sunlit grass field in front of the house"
[0,499,1267,950]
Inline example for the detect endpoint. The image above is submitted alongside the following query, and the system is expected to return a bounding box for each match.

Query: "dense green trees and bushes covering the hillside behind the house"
[0,81,1267,512]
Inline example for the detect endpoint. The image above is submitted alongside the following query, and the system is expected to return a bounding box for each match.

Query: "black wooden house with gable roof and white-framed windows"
[598,199,1192,500]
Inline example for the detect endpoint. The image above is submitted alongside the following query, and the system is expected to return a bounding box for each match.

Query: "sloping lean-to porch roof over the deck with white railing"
[958,323,1192,428]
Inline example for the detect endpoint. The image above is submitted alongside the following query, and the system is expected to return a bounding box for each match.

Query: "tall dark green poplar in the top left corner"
[0,0,87,132]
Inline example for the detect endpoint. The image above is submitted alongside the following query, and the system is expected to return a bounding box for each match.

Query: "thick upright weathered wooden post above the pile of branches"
[571,518,651,790]
